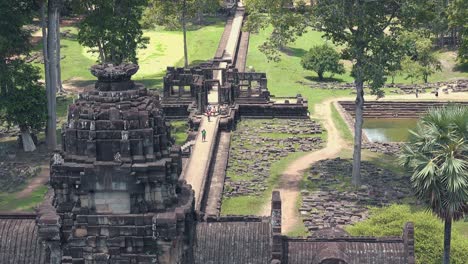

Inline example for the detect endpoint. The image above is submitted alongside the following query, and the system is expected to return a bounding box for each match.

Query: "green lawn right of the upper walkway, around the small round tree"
[247,27,468,113]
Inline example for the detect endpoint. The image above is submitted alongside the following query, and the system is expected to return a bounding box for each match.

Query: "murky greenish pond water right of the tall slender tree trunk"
[363,118,418,142]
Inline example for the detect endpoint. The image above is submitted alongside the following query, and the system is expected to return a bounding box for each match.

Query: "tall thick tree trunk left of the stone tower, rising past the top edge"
[46,0,58,150]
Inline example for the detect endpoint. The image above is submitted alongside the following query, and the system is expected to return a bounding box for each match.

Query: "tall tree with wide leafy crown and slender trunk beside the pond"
[247,0,421,185]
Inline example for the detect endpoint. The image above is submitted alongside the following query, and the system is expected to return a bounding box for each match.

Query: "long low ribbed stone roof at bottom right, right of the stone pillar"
[286,236,408,264]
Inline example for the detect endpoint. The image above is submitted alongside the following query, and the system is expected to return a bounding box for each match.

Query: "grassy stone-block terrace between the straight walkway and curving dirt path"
[224,119,323,197]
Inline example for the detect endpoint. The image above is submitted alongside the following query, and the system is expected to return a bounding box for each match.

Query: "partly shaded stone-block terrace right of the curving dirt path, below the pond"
[299,158,412,231]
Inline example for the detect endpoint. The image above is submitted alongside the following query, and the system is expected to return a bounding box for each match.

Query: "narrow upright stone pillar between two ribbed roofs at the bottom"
[271,191,283,264]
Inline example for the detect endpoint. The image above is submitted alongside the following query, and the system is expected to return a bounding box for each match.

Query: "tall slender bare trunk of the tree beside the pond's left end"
[352,80,364,186]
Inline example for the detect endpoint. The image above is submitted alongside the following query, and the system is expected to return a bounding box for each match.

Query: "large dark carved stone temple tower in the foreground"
[38,64,195,264]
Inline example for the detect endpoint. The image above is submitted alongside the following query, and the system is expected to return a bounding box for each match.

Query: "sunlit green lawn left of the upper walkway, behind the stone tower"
[35,18,225,88]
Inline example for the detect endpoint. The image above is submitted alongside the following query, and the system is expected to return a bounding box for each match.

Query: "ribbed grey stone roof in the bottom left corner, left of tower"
[0,214,47,264]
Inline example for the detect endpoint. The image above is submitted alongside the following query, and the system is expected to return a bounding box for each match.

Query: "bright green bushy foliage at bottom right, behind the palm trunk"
[346,205,468,264]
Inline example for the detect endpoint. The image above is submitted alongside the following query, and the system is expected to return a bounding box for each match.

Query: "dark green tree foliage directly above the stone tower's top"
[78,0,148,64]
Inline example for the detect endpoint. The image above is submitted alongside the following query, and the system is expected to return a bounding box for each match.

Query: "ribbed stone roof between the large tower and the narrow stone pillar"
[194,221,272,264]
